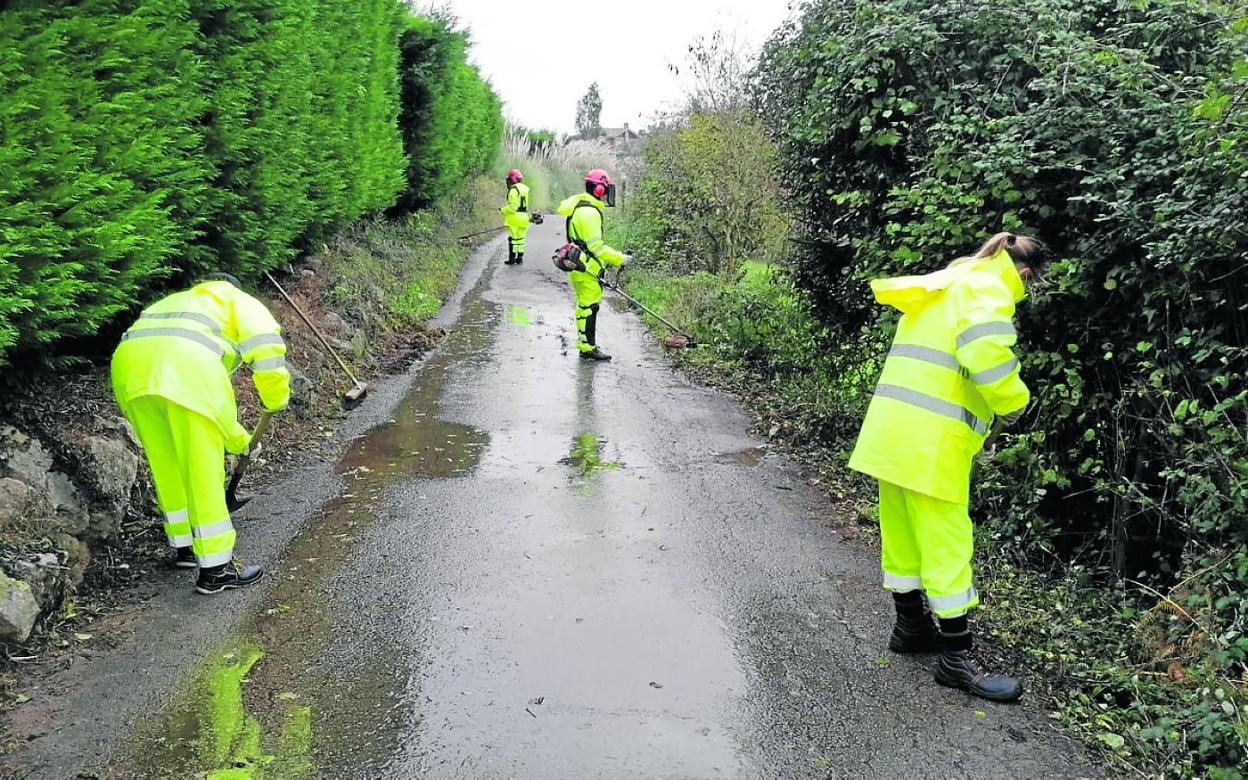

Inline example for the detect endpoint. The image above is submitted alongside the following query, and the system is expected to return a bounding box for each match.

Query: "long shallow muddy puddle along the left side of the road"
[121,265,499,780]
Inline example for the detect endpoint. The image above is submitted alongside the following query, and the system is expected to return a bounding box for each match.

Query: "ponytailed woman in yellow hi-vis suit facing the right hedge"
[850,233,1041,701]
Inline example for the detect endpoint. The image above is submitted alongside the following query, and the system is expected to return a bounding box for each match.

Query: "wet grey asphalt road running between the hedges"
[7,221,1093,778]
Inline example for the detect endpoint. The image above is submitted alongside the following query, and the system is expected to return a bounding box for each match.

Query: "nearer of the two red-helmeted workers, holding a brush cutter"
[558,168,633,361]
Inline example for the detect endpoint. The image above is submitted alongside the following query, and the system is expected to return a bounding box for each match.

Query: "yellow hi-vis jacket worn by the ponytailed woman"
[850,251,1031,504]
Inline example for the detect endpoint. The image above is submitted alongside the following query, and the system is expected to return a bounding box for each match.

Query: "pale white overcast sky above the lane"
[438,0,789,132]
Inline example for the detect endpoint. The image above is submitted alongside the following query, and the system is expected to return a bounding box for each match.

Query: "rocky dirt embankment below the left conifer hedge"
[0,198,496,709]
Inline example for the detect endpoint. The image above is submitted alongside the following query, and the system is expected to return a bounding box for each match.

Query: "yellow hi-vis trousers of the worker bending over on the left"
[121,396,236,567]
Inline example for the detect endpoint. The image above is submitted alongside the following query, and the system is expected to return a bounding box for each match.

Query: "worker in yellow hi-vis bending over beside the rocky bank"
[112,273,291,594]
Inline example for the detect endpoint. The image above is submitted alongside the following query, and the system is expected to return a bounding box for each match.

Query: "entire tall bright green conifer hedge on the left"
[0,0,500,363]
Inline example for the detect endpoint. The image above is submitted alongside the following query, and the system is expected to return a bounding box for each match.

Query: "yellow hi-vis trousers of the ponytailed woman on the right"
[880,480,980,618]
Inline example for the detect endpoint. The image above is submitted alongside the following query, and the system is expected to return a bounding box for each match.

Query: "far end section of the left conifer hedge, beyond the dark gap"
[399,16,503,211]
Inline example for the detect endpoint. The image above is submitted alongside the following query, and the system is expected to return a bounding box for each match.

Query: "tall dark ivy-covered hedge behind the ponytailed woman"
[759,0,1248,766]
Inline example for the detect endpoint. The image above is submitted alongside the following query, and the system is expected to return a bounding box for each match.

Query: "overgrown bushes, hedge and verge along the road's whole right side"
[631,0,1248,778]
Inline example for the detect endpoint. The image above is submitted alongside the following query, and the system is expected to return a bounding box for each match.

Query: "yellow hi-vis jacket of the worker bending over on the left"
[112,281,291,453]
